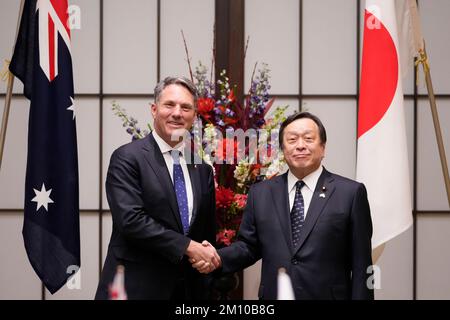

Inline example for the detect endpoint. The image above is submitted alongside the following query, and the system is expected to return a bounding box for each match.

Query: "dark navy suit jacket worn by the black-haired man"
[219,169,373,299]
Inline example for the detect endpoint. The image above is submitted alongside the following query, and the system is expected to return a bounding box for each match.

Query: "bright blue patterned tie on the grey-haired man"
[172,150,189,234]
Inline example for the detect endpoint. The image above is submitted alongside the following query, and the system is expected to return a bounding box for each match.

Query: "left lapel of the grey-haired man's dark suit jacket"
[143,134,183,233]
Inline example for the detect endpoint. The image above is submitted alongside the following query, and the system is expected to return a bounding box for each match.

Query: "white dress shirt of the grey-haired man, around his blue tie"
[152,130,194,223]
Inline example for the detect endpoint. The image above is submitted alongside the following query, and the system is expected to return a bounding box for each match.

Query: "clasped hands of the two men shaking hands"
[186,240,222,273]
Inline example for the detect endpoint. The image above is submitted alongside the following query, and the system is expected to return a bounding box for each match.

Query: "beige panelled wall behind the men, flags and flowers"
[0,0,450,299]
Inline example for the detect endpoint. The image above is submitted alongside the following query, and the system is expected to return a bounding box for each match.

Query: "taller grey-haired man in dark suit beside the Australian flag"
[95,77,219,300]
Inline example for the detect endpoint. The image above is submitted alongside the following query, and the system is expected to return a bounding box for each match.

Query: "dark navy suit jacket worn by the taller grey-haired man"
[96,134,216,299]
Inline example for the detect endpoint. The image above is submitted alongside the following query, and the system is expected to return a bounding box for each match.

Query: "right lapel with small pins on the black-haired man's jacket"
[294,168,335,253]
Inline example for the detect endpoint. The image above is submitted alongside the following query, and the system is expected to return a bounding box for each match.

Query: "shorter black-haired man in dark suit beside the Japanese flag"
[194,112,373,299]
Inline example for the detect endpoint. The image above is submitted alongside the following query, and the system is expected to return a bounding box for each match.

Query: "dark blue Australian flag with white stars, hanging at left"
[9,0,80,294]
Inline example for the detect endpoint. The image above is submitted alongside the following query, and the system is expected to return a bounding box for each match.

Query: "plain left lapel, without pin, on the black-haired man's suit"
[271,173,292,251]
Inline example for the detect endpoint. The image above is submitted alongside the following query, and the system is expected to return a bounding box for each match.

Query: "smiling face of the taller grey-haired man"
[151,84,196,147]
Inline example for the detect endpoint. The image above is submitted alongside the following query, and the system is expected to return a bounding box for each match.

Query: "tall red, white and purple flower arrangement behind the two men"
[112,38,288,246]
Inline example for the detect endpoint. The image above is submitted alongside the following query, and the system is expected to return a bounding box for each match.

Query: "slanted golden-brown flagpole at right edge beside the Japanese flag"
[418,47,450,206]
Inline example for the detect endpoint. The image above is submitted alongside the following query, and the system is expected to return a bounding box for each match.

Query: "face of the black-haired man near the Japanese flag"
[283,118,325,179]
